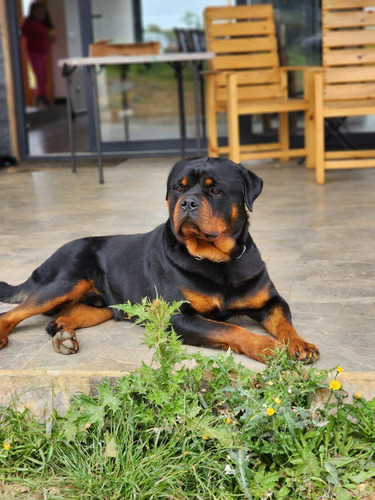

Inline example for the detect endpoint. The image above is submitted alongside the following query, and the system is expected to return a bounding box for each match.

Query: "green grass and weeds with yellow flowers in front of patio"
[0,300,375,500]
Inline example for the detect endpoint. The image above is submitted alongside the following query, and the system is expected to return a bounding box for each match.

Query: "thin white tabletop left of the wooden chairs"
[57,52,215,67]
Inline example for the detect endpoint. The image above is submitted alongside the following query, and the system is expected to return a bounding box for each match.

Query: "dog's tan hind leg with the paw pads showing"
[46,304,112,354]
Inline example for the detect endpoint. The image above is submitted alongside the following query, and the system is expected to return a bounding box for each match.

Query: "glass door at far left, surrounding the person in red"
[15,0,89,157]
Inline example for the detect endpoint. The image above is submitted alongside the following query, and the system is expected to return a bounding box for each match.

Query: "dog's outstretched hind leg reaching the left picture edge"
[0,280,93,349]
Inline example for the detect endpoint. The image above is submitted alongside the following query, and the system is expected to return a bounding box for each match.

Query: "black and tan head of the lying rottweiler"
[167,158,263,262]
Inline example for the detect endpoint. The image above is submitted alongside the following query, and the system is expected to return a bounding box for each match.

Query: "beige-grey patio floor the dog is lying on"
[0,158,375,414]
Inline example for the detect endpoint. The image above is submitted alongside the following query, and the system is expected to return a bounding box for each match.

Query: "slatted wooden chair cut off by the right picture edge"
[312,0,375,184]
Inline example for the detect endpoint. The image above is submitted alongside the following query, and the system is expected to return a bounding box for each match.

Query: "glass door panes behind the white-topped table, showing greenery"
[91,0,233,153]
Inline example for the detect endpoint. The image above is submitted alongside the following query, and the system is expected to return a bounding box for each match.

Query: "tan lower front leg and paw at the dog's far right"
[262,306,320,362]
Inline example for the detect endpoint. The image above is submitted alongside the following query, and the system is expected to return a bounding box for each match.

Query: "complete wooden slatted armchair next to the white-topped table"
[204,4,313,162]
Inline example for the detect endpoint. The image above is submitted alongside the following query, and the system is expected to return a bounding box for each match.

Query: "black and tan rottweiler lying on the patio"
[0,158,319,362]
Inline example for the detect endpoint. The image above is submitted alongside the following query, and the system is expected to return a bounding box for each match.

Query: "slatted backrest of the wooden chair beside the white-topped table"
[204,4,285,101]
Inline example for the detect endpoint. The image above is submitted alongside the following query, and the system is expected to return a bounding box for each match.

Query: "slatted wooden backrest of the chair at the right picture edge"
[322,0,375,101]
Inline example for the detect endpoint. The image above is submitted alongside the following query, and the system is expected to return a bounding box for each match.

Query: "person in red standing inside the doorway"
[21,2,55,106]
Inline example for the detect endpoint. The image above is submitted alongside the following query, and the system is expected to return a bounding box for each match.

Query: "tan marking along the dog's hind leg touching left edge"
[0,280,93,348]
